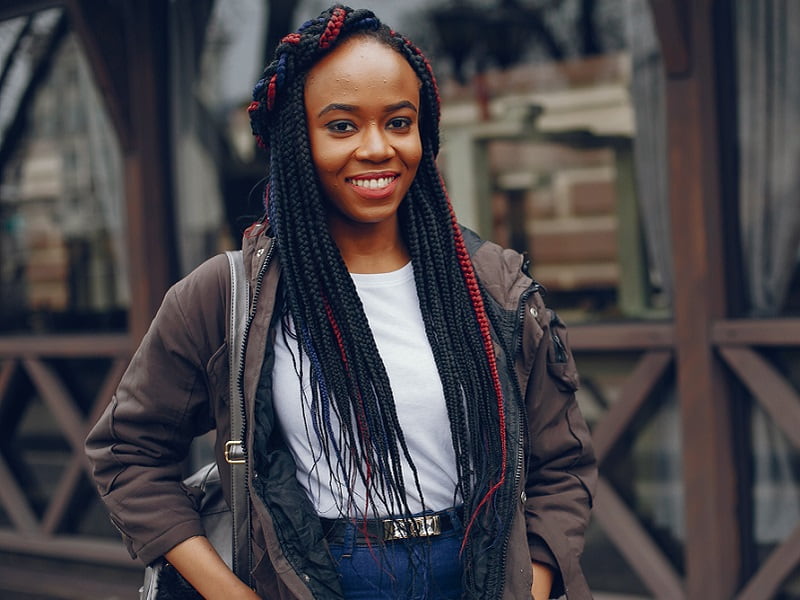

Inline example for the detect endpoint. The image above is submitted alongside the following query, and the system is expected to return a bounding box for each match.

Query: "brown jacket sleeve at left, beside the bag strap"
[86,256,228,564]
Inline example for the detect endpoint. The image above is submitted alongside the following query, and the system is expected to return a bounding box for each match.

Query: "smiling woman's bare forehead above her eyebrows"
[305,37,421,109]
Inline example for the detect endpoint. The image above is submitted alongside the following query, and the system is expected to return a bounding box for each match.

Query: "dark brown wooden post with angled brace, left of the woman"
[66,0,177,345]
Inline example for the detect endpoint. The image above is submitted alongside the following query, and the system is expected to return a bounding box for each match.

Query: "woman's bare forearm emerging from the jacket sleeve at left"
[164,536,259,600]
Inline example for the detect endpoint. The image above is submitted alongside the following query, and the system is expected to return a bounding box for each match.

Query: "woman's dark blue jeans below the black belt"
[330,511,464,600]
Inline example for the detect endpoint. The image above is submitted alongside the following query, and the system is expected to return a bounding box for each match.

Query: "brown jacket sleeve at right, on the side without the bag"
[523,293,597,597]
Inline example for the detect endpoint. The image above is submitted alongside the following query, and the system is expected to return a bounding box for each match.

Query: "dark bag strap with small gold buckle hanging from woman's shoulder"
[225,251,251,585]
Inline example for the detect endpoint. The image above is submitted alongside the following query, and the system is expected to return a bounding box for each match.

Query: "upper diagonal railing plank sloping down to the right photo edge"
[719,347,800,450]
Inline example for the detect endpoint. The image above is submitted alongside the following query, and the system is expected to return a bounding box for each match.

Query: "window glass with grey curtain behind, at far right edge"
[730,0,800,317]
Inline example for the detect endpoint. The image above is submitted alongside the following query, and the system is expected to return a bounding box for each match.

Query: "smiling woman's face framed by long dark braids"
[305,37,422,237]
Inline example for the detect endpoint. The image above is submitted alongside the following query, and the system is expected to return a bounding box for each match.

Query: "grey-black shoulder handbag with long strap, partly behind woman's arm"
[139,251,250,600]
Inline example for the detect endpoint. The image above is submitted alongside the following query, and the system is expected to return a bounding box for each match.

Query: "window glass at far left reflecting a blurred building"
[0,9,129,333]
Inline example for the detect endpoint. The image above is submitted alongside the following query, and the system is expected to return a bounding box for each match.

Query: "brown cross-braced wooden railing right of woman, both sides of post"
[570,319,800,600]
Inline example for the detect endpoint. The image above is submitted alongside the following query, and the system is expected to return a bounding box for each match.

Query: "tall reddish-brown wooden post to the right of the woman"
[651,0,741,600]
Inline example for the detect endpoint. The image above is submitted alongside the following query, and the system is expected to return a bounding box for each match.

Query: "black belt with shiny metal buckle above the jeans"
[320,506,464,544]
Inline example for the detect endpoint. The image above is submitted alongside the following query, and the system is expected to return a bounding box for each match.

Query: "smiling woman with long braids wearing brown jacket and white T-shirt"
[87,6,596,600]
